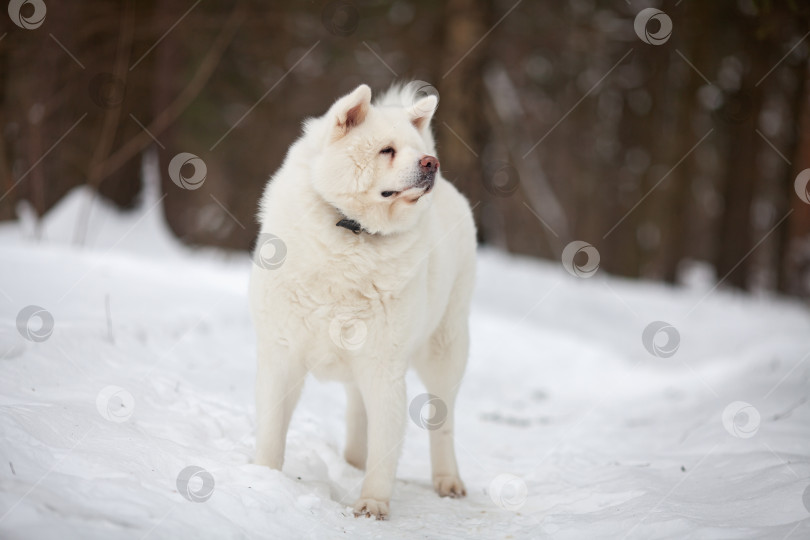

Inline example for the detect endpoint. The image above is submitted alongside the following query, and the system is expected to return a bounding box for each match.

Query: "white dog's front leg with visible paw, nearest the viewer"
[354,362,406,519]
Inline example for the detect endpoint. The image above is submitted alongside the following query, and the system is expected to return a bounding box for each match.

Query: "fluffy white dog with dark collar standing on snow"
[250,85,475,519]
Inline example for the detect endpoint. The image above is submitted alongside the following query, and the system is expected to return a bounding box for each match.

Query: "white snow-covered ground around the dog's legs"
[0,182,810,539]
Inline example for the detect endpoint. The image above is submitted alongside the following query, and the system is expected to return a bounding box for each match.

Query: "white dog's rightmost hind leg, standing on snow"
[414,298,469,497]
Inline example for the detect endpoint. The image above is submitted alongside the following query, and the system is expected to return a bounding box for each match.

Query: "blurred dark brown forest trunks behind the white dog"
[0,0,810,296]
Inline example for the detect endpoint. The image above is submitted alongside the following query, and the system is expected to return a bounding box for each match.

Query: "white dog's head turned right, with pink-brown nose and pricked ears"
[308,85,439,234]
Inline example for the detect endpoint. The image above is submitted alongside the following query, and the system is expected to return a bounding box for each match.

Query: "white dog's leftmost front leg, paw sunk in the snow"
[254,338,307,470]
